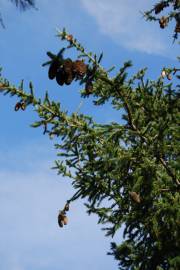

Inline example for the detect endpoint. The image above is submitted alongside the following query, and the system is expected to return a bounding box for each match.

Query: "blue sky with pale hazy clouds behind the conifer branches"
[0,0,178,270]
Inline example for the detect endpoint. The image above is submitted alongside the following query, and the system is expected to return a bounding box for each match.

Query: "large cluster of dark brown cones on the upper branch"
[48,58,87,86]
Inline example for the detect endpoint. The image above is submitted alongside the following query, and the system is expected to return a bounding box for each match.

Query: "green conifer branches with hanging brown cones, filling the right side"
[0,1,180,270]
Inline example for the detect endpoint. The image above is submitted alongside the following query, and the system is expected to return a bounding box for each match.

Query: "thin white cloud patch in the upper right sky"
[81,0,179,56]
